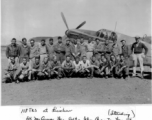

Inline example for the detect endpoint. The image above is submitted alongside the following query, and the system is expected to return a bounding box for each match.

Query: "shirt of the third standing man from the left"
[30,44,39,59]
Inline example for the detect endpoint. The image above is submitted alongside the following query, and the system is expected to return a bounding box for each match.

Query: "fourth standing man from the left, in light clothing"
[39,39,48,64]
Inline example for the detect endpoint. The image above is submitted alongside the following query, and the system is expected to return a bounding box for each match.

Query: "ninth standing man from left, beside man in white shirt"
[80,38,88,59]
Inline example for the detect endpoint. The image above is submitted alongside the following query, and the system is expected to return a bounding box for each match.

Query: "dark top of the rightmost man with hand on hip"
[131,42,148,54]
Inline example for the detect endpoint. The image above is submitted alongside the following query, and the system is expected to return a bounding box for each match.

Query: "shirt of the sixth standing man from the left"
[54,43,65,54]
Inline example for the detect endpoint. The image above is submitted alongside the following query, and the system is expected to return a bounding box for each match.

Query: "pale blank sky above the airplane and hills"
[1,0,151,45]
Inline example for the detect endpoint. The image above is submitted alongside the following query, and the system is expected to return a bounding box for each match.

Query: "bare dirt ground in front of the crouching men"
[1,52,152,105]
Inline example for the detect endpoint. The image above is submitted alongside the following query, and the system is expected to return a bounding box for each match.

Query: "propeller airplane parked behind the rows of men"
[28,13,152,68]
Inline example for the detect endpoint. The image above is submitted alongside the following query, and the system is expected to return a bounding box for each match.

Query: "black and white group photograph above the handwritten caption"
[1,0,152,106]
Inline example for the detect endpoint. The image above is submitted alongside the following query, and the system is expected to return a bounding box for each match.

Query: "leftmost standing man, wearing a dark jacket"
[6,38,20,64]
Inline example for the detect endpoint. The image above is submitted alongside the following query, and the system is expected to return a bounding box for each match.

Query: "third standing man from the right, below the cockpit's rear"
[111,39,121,56]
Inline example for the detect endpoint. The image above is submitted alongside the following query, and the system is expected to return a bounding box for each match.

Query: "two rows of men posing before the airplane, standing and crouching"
[5,33,148,83]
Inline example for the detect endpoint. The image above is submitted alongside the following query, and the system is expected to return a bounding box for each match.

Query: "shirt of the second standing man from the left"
[20,45,30,57]
